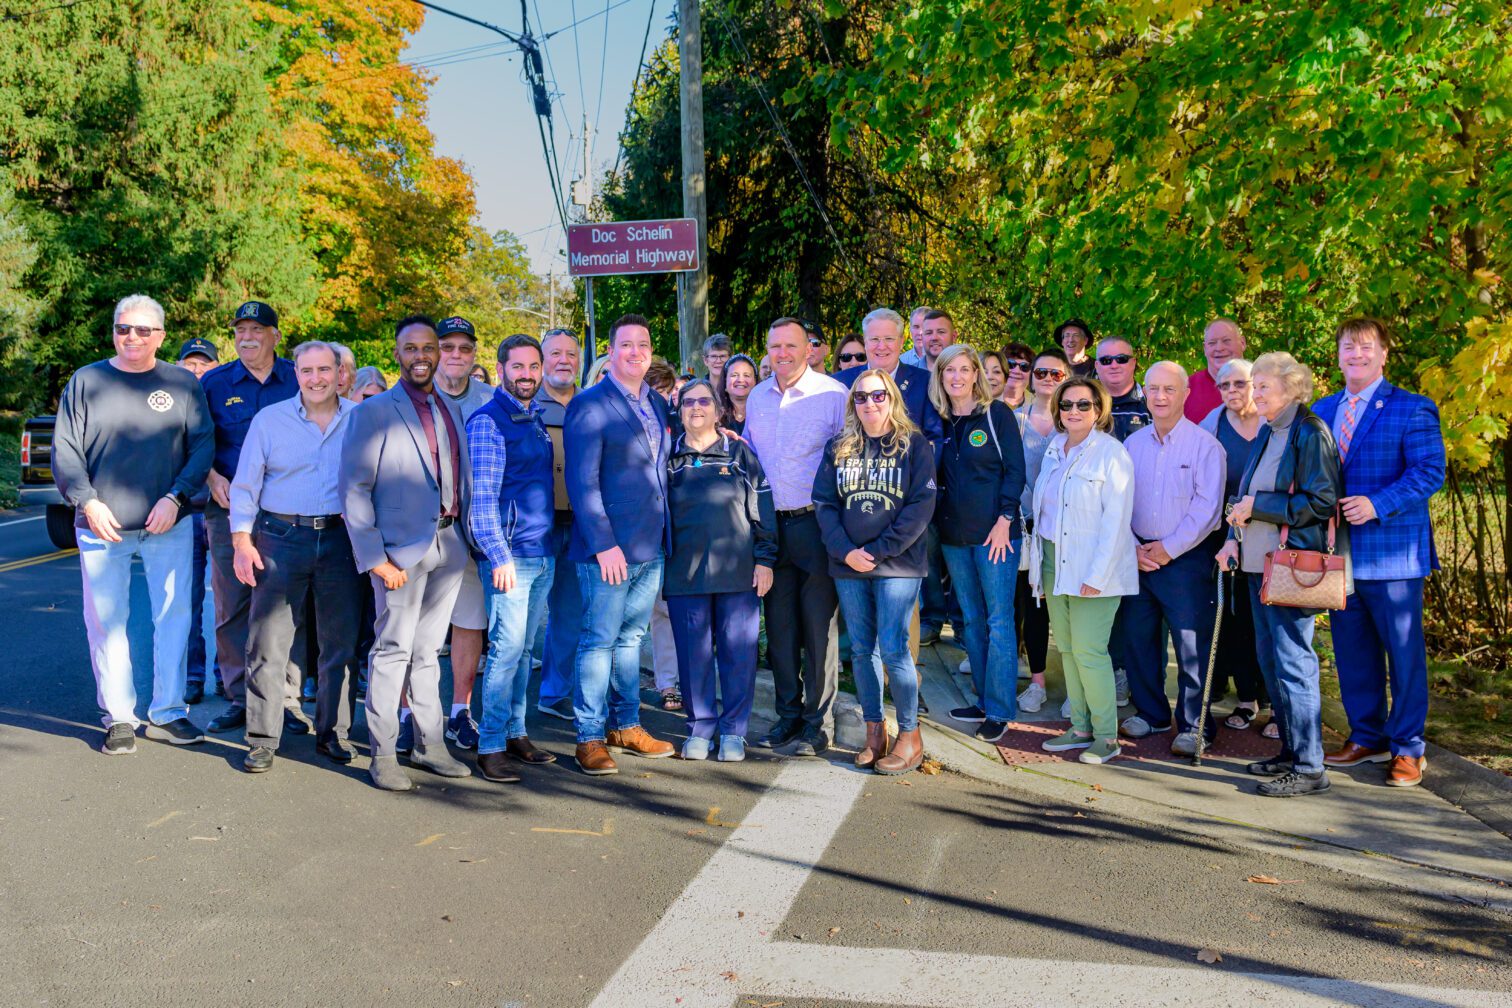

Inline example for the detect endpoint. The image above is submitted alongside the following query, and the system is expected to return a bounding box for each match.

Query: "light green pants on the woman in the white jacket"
[1040,540,1120,741]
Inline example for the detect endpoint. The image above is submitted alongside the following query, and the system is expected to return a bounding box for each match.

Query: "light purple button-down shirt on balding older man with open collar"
[1123,417,1225,559]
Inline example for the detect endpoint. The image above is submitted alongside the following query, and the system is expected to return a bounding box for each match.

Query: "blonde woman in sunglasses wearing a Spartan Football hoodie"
[813,369,934,774]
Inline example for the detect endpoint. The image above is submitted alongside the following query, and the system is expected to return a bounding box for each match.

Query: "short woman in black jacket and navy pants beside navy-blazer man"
[662,378,777,762]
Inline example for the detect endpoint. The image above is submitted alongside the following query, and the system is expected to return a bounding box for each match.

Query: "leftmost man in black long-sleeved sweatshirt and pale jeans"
[53,295,215,756]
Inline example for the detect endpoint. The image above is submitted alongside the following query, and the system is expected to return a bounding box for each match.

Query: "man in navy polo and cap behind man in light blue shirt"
[201,301,302,733]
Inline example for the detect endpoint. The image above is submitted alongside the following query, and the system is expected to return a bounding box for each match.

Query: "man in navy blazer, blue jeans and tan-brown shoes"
[562,314,673,775]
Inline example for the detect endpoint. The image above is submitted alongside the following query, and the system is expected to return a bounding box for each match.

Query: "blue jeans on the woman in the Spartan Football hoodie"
[835,577,919,731]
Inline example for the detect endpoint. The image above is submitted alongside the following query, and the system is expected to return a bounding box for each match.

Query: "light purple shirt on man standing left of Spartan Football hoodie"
[745,367,848,511]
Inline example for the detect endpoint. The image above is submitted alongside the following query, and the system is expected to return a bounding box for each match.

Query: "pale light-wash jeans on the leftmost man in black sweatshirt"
[74,521,194,728]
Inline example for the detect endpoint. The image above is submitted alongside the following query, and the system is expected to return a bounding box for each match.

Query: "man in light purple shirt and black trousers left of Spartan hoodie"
[745,317,845,756]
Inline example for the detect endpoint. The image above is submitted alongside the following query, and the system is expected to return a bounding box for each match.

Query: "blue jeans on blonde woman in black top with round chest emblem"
[940,541,1021,722]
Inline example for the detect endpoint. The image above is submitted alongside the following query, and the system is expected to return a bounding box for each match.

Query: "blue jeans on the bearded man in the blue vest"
[478,556,556,756]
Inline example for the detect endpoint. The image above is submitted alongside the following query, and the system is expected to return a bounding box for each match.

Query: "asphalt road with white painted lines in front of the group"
[0,511,1512,1008]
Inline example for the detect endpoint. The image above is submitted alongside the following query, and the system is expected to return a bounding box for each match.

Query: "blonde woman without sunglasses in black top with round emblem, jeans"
[930,343,1024,742]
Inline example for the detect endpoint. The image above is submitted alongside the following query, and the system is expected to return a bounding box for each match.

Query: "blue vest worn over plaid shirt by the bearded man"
[475,391,555,556]
